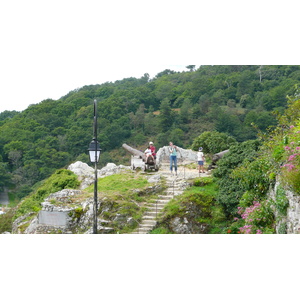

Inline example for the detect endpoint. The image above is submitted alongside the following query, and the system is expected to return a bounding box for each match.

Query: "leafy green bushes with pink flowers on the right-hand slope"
[214,92,300,233]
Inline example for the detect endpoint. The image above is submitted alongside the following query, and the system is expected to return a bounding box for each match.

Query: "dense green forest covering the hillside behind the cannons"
[0,65,300,203]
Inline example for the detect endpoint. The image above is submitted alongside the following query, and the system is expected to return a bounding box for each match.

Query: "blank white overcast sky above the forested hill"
[0,0,298,112]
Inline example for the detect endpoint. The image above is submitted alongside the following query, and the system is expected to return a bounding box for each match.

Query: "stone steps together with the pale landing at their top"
[132,163,209,234]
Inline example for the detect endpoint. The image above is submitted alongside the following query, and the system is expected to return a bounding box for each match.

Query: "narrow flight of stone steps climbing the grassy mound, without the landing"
[132,172,183,234]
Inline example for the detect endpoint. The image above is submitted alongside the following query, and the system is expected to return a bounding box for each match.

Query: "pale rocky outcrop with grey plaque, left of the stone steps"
[13,162,163,234]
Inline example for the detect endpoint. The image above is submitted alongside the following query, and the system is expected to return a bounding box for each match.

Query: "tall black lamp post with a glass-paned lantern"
[88,100,101,233]
